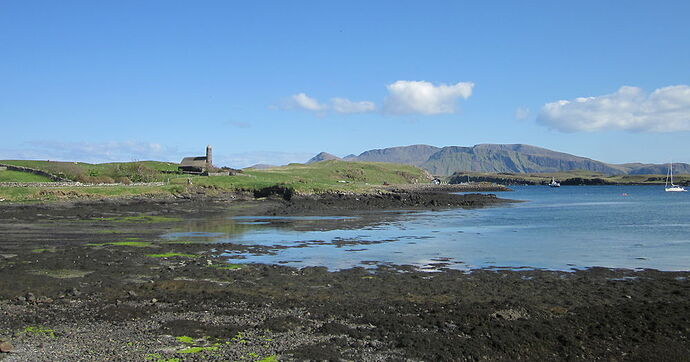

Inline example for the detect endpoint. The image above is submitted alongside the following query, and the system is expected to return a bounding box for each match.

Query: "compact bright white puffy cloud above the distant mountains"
[385,80,474,114]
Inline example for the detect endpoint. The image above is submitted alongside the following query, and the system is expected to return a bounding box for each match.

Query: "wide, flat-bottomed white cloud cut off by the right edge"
[537,85,690,132]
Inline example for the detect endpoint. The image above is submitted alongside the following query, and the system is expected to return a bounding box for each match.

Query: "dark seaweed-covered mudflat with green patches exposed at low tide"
[0,192,690,361]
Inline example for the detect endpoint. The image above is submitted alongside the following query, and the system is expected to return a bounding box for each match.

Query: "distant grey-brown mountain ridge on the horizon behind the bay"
[308,144,690,176]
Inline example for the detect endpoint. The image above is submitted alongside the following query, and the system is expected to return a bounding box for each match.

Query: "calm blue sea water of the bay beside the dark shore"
[165,186,690,270]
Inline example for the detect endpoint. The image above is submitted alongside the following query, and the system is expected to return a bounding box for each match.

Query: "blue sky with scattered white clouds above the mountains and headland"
[0,0,690,167]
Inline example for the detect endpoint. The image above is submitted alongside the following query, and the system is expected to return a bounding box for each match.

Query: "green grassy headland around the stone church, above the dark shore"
[0,160,429,202]
